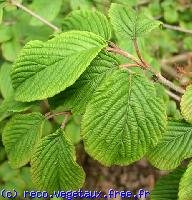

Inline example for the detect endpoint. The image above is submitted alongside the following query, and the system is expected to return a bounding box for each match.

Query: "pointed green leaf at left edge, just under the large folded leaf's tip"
[0,96,33,121]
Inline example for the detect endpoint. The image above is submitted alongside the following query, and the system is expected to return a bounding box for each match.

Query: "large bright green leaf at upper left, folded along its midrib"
[11,31,107,102]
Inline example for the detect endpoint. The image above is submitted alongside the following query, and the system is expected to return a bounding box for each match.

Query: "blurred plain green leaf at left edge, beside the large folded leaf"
[0,62,13,98]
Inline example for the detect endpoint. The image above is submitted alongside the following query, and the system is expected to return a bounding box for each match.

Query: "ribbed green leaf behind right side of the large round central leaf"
[147,121,192,170]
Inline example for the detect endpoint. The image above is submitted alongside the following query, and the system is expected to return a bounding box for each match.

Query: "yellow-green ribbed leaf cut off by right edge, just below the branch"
[181,85,192,123]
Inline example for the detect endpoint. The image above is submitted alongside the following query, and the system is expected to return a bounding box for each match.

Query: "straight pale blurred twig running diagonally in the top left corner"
[10,0,60,31]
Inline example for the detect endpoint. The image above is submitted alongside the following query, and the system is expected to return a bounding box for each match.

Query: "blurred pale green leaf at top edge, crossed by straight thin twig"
[31,0,62,26]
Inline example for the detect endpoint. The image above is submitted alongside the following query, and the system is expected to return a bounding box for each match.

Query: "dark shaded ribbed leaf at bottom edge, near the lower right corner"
[151,168,186,200]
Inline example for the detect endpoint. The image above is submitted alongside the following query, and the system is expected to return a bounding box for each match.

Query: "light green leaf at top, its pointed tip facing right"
[109,3,162,39]
